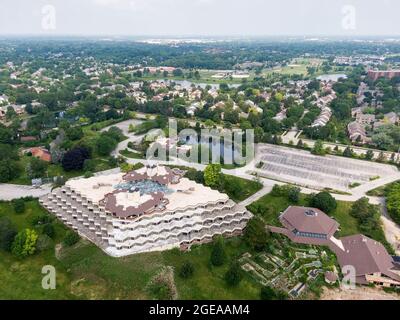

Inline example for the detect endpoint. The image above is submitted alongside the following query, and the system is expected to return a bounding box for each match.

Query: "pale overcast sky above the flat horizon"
[0,0,400,36]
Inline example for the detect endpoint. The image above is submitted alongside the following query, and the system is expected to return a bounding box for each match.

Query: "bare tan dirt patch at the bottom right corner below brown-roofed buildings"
[321,287,400,300]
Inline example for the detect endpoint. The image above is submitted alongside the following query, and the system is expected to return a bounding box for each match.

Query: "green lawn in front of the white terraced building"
[0,200,260,299]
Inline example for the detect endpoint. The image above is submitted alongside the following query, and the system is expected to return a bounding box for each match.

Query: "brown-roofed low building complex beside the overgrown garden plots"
[267,207,400,287]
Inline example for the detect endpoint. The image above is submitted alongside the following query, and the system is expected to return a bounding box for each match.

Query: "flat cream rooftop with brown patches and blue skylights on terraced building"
[66,167,229,218]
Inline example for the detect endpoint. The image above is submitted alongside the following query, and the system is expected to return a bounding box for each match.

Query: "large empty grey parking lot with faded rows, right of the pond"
[257,145,398,191]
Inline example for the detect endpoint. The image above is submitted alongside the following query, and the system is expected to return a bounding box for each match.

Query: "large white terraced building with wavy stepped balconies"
[40,166,251,257]
